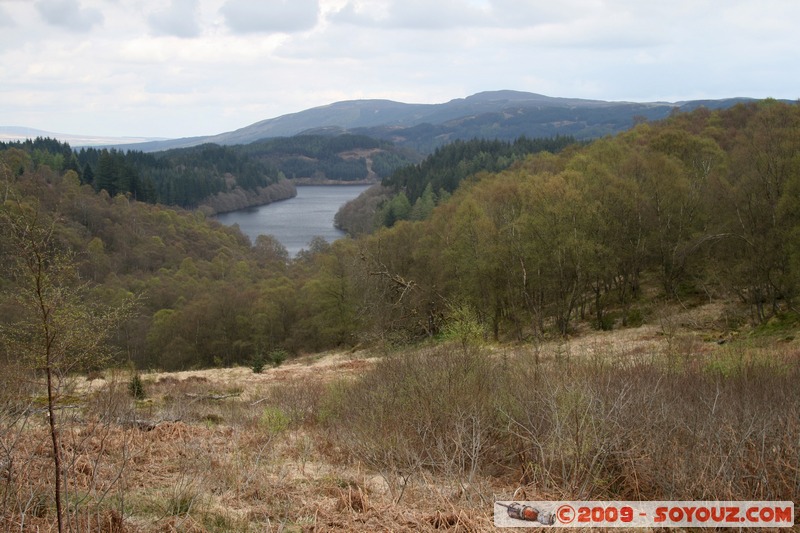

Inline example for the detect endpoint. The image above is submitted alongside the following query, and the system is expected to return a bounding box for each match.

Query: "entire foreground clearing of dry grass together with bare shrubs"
[0,304,800,532]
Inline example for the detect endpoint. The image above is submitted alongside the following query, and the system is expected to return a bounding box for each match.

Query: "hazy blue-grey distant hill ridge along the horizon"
[0,90,768,154]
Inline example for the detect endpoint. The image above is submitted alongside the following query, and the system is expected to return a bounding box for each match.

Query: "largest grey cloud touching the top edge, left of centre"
[220,0,319,33]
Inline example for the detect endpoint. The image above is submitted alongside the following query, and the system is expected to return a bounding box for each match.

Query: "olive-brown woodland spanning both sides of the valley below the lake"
[0,100,800,369]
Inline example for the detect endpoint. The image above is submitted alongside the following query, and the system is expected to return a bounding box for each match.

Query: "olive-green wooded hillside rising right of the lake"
[362,101,800,339]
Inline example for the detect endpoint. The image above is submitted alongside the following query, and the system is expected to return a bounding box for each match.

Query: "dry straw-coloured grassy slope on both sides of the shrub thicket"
[3,298,800,531]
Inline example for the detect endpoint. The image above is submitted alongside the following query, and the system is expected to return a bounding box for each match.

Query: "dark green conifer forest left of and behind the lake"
[0,135,414,208]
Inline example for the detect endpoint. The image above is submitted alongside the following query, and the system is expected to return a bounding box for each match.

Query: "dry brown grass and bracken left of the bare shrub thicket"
[0,354,496,532]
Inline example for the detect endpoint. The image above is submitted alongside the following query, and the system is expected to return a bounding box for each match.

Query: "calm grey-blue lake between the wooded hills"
[216,185,368,257]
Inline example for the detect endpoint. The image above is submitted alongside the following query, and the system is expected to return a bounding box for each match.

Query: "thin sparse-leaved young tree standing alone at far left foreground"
[0,195,132,531]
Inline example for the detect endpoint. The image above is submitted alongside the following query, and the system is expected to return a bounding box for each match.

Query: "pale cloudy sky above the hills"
[0,0,800,138]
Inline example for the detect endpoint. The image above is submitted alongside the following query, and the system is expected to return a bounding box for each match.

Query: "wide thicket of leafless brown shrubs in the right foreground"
[320,342,800,501]
